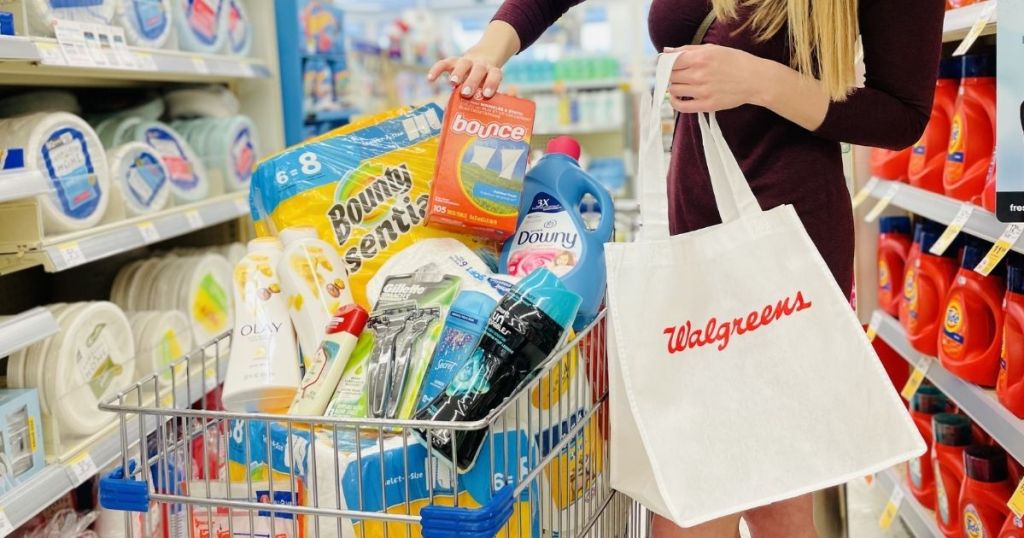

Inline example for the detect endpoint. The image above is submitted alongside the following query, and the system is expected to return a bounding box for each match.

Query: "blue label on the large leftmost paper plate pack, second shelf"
[41,127,102,218]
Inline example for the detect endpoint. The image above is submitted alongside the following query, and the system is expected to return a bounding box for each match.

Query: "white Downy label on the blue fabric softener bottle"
[508,192,583,277]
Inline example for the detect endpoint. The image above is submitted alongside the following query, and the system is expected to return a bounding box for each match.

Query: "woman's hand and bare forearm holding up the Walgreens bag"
[666,45,830,131]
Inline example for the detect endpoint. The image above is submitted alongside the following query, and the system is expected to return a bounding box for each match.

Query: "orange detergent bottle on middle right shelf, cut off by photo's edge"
[995,252,1024,418]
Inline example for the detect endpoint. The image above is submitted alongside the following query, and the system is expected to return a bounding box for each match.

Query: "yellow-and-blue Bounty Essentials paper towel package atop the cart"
[250,104,495,309]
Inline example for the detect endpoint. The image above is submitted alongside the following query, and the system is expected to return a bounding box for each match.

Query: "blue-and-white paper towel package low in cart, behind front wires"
[228,421,541,538]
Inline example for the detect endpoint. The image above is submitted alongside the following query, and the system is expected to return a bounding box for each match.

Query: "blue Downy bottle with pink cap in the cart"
[500,137,615,329]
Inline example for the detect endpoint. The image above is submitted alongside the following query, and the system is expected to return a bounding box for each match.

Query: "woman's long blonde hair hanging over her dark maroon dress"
[712,0,859,100]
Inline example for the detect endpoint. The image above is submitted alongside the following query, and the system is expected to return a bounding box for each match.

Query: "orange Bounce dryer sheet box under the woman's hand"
[427,92,537,240]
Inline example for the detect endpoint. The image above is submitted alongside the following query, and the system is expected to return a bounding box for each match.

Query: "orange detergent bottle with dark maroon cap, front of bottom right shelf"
[959,445,1014,538]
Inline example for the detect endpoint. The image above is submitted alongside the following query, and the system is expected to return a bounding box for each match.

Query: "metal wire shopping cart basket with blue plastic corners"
[100,314,648,538]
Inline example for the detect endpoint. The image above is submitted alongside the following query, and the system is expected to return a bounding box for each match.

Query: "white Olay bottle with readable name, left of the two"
[221,238,301,413]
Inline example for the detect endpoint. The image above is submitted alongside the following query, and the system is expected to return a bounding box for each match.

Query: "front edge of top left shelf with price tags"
[0,37,271,86]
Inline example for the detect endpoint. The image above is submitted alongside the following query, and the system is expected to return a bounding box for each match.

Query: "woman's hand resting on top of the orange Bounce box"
[427,20,520,98]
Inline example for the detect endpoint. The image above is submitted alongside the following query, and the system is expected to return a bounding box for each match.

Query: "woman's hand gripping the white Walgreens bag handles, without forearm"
[666,45,771,114]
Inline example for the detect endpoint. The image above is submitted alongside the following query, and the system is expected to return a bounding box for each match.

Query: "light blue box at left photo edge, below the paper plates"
[0,388,45,494]
